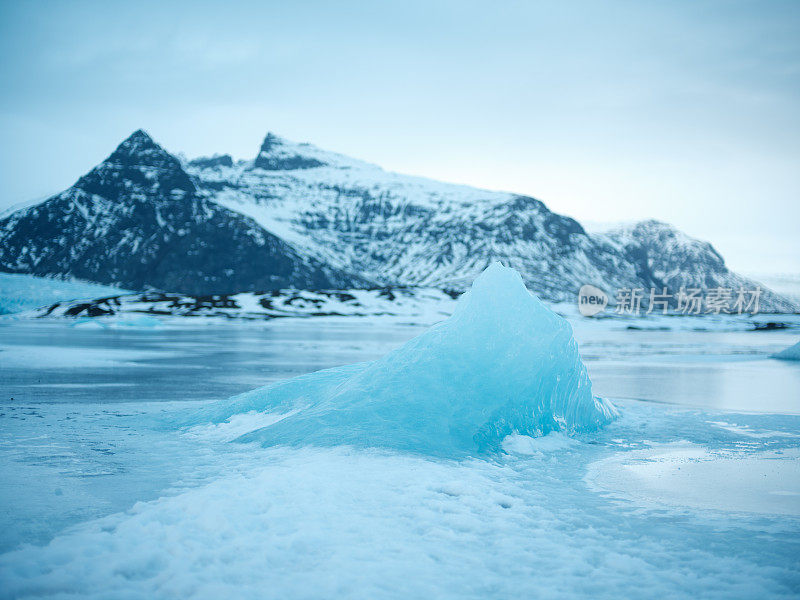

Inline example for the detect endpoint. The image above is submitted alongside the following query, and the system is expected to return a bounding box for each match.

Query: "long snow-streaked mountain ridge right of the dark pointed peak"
[187,134,796,311]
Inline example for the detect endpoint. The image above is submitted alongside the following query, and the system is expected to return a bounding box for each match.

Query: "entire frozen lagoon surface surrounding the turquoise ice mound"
[0,300,800,598]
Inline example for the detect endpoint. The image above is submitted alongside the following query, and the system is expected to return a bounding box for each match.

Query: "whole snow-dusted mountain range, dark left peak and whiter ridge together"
[0,131,795,311]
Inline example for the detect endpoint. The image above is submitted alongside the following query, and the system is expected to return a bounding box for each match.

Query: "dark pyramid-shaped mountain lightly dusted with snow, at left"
[0,131,366,293]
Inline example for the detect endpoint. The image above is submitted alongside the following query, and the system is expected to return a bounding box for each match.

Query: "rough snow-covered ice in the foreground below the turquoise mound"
[0,434,800,600]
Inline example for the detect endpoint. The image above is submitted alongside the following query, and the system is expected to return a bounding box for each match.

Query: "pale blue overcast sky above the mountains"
[0,0,800,273]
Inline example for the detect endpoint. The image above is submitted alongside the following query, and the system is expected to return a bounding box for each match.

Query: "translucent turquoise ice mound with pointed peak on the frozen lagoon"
[191,263,616,456]
